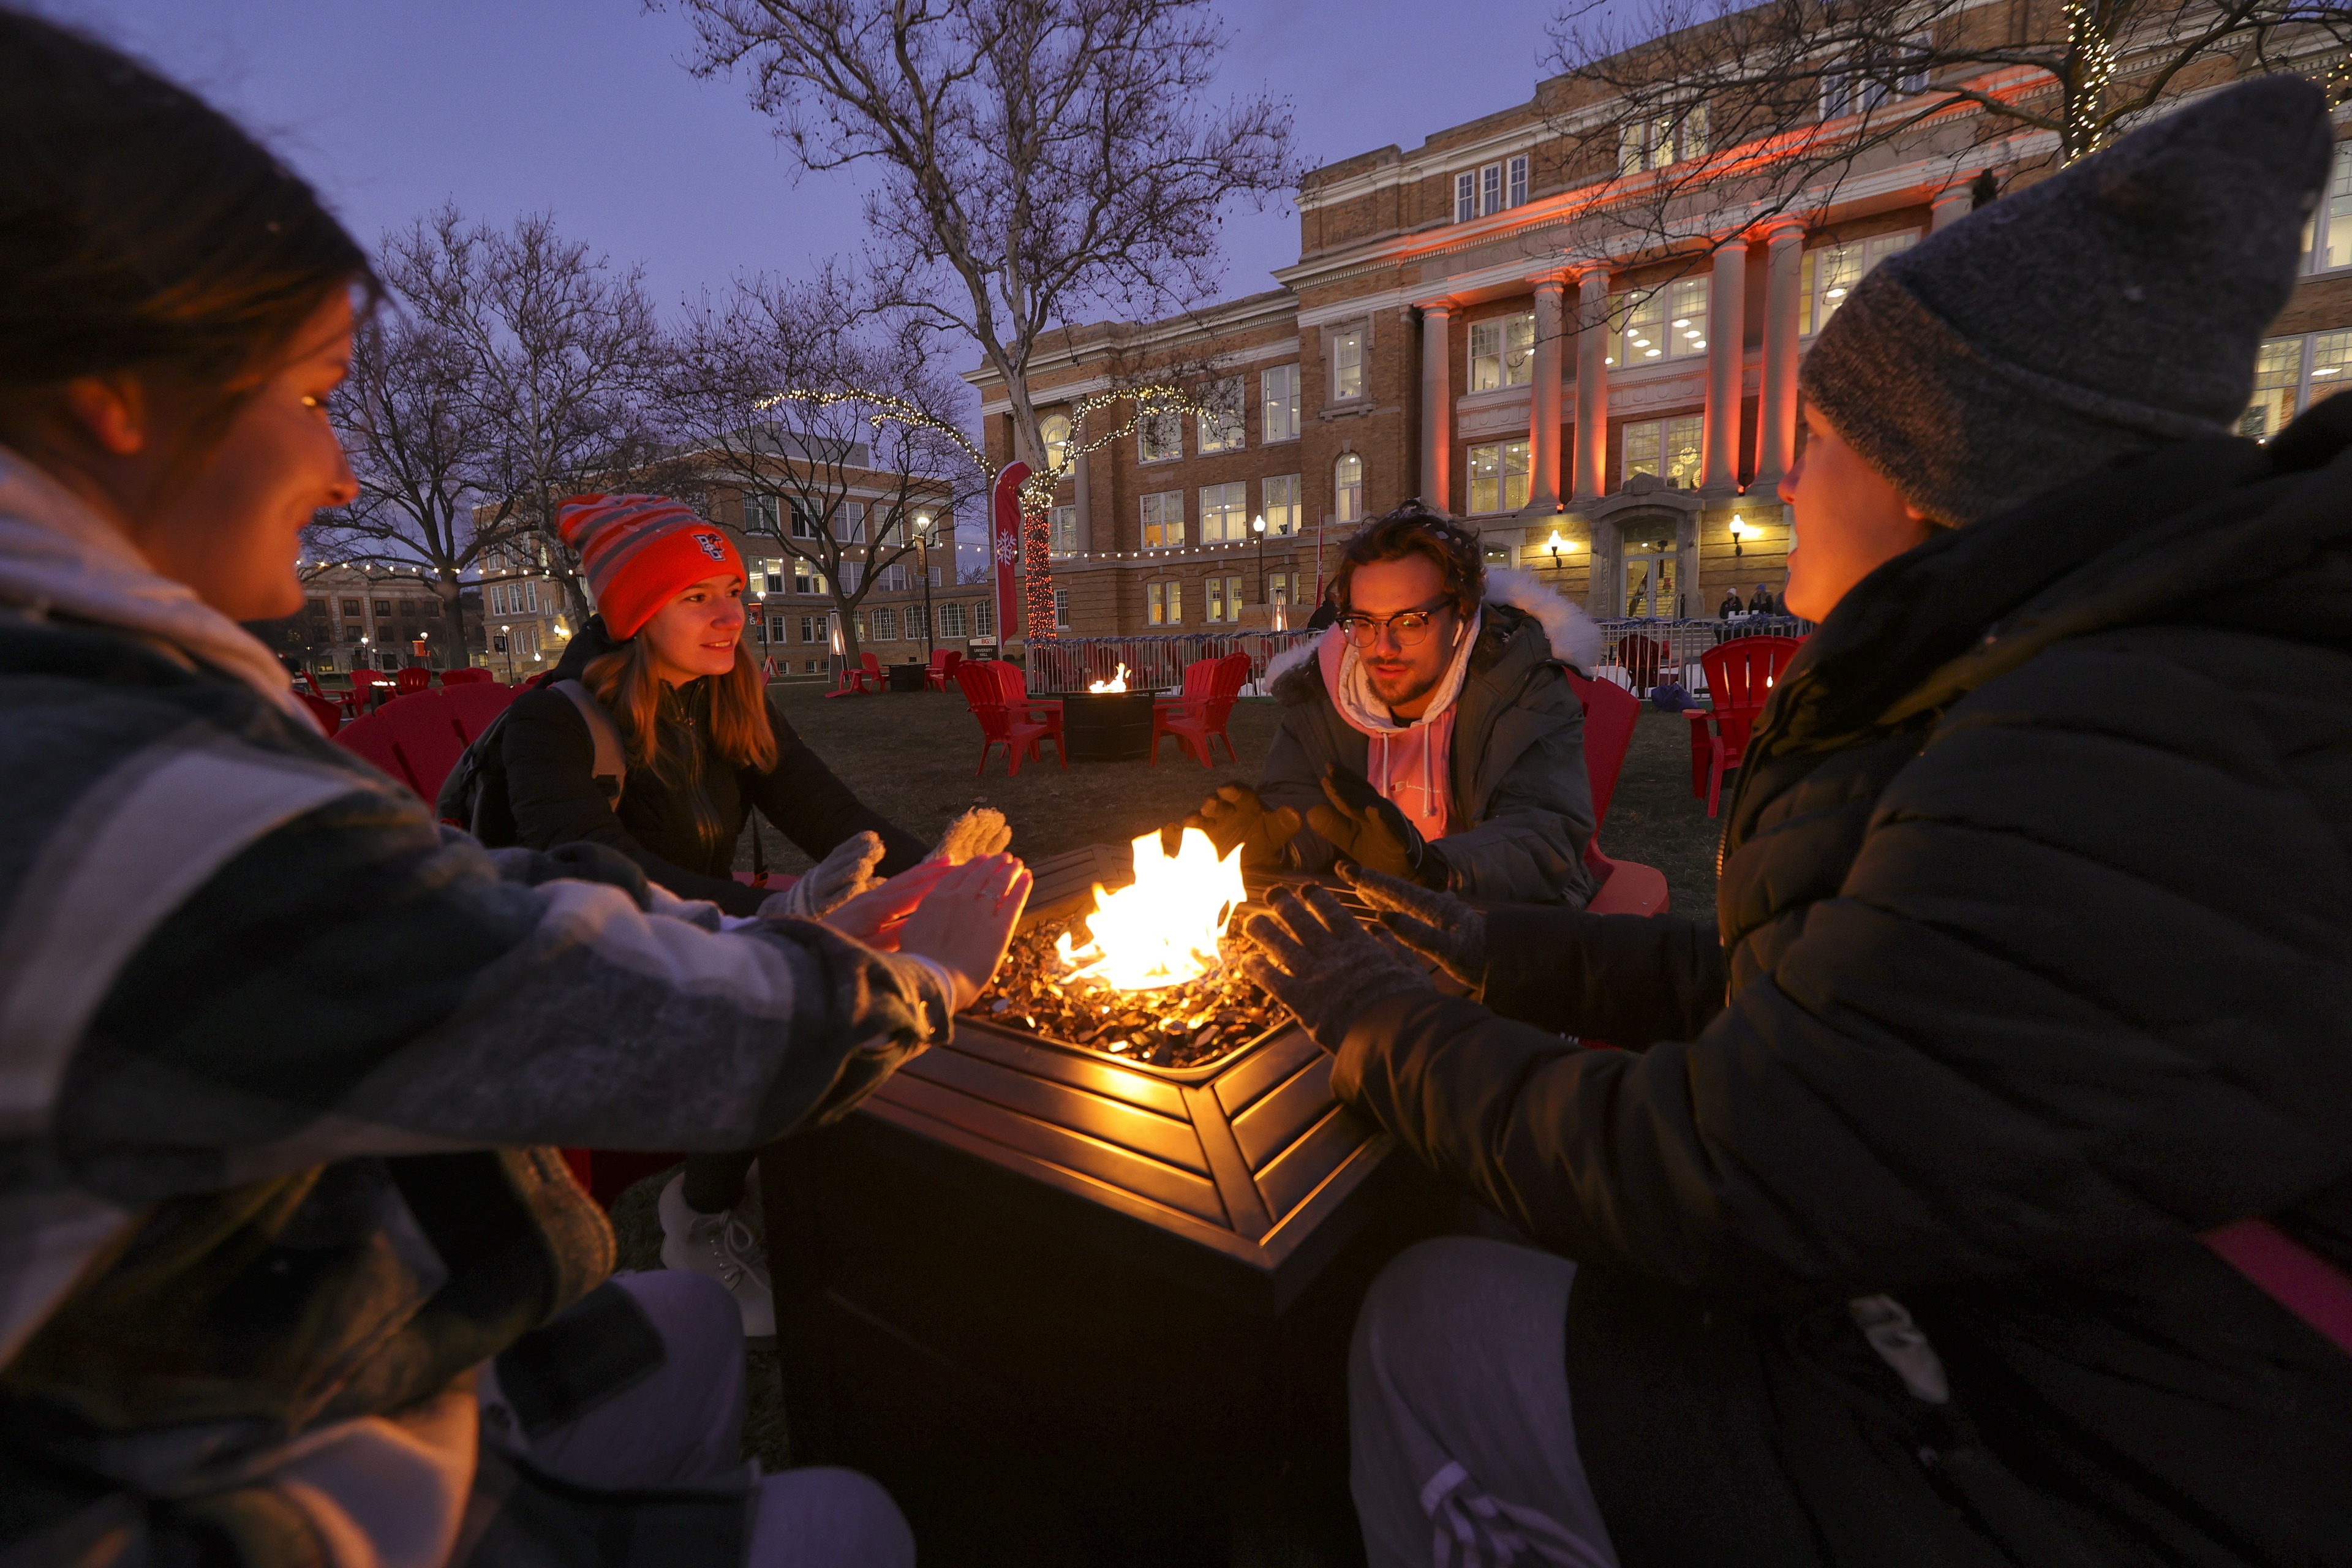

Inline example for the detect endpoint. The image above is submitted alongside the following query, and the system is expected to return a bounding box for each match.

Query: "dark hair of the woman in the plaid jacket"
[0,9,376,449]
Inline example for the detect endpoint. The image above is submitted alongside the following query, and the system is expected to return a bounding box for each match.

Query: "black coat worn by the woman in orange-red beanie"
[484,616,929,914]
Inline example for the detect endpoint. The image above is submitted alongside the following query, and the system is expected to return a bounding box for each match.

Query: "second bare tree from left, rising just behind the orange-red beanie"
[383,207,661,625]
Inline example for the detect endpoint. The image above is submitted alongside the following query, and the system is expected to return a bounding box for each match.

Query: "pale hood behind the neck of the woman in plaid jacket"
[0,447,320,729]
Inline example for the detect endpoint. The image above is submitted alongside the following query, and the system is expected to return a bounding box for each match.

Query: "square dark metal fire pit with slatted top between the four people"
[760,844,1451,1568]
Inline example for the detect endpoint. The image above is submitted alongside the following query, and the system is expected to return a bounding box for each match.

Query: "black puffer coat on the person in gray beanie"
[1333,409,2352,1568]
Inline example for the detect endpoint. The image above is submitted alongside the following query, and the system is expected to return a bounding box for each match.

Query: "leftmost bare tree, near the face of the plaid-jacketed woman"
[303,310,515,661]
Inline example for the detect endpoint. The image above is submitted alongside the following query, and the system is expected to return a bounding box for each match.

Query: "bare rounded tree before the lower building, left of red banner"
[658,270,988,658]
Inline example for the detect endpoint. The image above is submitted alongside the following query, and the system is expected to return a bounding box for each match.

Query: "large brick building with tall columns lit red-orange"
[967,29,2352,635]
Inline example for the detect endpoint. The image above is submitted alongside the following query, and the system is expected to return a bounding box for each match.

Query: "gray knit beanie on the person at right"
[1797,75,2331,524]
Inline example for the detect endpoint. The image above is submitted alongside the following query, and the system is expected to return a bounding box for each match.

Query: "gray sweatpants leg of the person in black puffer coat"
[1348,1237,1616,1568]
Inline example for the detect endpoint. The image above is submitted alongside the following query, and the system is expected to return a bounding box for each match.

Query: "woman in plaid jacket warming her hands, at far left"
[0,9,1028,1568]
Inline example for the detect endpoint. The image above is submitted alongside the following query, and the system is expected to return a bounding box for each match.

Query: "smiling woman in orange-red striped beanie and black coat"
[480,496,1011,1340]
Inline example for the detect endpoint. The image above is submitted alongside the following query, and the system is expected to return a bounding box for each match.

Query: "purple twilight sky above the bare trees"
[55,0,1589,360]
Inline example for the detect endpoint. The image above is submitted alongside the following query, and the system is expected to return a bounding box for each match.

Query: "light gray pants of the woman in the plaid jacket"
[482,1270,915,1568]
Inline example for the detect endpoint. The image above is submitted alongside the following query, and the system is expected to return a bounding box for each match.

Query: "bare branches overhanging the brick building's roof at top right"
[1543,0,2352,256]
